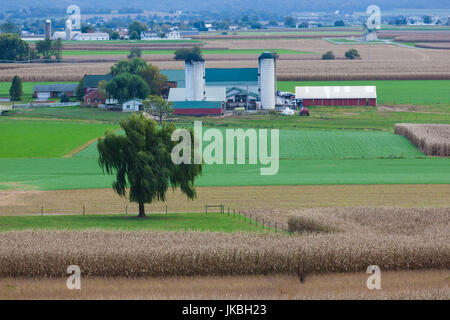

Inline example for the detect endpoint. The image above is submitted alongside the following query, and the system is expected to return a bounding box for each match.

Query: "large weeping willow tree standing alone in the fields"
[97,115,202,218]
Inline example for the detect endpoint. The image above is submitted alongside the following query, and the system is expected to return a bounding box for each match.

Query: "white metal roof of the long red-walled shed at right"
[295,86,377,99]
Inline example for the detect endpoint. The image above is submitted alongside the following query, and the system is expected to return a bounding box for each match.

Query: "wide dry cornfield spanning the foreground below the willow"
[0,208,450,277]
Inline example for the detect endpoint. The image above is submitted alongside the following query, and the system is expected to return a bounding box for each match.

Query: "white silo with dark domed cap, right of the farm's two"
[258,52,277,109]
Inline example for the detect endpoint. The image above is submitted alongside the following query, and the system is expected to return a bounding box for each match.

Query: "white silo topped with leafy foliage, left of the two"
[185,60,205,101]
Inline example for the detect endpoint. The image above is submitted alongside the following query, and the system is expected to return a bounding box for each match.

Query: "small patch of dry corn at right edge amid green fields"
[394,123,450,157]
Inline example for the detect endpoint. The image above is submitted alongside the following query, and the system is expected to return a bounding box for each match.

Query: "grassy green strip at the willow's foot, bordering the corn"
[0,212,268,232]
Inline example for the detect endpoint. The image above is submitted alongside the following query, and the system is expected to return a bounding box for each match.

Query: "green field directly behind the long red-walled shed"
[278,80,450,105]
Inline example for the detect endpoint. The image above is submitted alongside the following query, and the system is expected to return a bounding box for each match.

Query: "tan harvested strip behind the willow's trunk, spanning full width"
[0,184,450,216]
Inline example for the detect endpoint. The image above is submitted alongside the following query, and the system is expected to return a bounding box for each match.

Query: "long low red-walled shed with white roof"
[295,86,377,106]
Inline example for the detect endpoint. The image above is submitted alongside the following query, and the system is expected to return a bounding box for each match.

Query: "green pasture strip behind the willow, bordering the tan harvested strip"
[0,157,450,190]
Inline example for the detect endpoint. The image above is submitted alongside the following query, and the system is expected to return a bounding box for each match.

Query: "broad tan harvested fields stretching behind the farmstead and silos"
[0,39,450,81]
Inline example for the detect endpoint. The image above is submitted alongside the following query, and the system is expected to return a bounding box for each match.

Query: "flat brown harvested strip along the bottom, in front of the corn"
[0,270,450,300]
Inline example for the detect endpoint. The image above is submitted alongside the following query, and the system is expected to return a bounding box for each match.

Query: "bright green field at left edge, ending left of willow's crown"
[0,117,117,158]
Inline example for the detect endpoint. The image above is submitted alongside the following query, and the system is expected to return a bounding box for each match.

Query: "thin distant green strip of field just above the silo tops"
[63,49,317,56]
